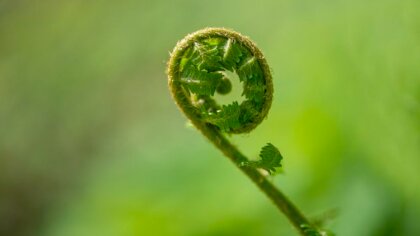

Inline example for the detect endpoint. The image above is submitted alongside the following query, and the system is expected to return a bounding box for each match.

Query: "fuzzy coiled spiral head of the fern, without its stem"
[168,28,273,133]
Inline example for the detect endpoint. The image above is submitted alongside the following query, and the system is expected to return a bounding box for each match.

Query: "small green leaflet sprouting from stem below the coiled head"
[242,143,283,174]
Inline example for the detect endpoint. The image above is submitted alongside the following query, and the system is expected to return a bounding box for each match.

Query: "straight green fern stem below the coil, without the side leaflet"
[195,122,315,235]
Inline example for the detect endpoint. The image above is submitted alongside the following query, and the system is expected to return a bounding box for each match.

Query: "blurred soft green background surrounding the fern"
[0,0,420,236]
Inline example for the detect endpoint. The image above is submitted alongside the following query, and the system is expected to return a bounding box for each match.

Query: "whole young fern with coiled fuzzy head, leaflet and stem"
[167,28,326,236]
